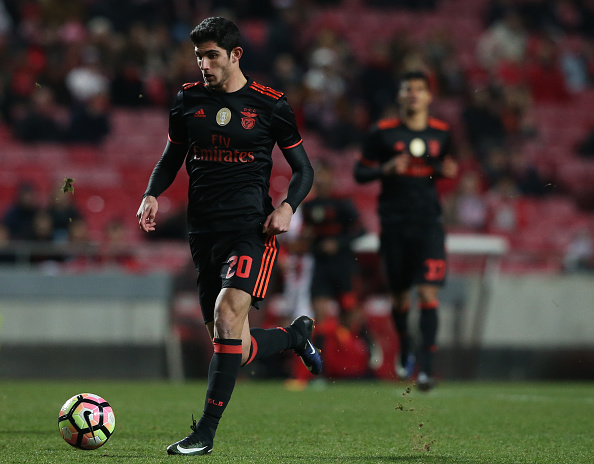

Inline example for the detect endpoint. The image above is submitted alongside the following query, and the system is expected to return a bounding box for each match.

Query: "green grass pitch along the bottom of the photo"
[0,380,594,464]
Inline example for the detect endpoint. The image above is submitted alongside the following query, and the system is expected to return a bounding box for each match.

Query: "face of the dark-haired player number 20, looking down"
[194,42,239,89]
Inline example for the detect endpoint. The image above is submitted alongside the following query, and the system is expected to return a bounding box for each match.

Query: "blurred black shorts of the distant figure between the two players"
[311,253,355,298]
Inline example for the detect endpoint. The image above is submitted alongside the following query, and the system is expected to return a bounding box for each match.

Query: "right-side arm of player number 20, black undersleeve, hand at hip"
[263,141,314,235]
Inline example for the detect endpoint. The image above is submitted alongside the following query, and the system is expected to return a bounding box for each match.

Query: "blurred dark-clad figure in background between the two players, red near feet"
[301,162,369,377]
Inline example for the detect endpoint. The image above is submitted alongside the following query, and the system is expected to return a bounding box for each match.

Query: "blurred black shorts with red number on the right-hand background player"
[380,224,446,292]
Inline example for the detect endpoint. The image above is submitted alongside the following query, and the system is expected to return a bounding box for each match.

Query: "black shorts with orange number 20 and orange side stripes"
[190,230,278,322]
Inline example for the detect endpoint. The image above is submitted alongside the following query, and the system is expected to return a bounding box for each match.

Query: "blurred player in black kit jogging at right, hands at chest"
[355,72,458,391]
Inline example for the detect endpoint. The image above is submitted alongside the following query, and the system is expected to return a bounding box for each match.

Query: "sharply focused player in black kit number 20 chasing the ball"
[137,17,322,455]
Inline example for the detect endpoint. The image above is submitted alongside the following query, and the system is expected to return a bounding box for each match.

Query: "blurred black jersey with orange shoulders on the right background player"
[360,118,451,225]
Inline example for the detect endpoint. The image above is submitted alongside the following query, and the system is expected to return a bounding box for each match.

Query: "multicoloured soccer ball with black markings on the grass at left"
[58,393,115,449]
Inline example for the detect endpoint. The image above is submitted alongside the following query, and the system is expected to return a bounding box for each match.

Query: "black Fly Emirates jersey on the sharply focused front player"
[169,79,302,233]
